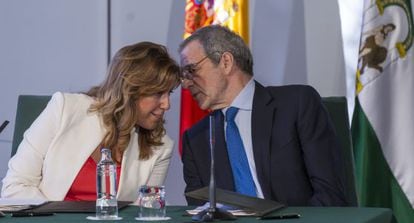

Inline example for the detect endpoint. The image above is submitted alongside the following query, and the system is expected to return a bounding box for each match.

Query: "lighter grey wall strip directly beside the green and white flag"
[303,0,346,96]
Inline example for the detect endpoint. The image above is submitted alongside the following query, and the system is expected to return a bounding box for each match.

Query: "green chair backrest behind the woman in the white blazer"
[11,95,51,156]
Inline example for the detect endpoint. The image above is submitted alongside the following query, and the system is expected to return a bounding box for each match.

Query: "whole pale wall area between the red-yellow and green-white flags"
[251,0,346,96]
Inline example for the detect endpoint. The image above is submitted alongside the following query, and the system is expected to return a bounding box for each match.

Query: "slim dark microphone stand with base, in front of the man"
[192,112,236,222]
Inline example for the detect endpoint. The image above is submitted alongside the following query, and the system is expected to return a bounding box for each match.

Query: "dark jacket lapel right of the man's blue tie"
[252,82,276,199]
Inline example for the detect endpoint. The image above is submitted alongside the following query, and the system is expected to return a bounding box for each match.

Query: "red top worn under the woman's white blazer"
[64,157,121,201]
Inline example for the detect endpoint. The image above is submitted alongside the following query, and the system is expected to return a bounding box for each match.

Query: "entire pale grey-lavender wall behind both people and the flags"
[0,0,345,204]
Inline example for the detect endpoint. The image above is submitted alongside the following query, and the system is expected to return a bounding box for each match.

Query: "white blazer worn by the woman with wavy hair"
[1,92,173,201]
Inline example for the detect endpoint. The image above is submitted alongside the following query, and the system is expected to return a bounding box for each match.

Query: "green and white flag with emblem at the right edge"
[352,0,414,223]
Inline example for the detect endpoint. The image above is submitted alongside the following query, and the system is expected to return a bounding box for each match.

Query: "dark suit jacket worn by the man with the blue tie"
[182,82,348,206]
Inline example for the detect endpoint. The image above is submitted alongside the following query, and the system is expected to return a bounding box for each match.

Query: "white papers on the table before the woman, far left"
[0,198,47,212]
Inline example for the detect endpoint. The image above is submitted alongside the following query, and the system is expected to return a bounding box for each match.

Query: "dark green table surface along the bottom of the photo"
[0,206,395,223]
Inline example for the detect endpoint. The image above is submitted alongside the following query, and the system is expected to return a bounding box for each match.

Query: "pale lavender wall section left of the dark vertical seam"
[0,0,107,199]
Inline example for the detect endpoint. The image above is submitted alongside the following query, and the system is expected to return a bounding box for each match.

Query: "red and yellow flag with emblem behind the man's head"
[179,0,249,154]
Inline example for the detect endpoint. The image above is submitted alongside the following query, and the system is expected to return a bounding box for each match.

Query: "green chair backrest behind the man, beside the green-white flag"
[322,97,358,206]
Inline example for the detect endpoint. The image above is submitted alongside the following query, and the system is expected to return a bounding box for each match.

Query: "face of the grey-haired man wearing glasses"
[180,40,227,110]
